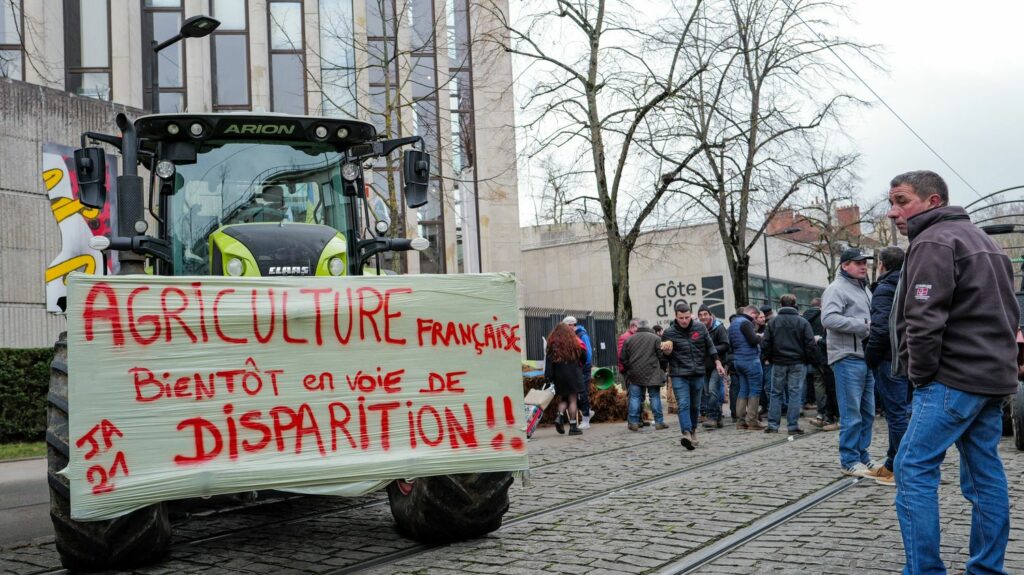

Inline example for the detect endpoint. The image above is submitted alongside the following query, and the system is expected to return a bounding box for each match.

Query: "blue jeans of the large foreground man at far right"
[896,382,1010,575]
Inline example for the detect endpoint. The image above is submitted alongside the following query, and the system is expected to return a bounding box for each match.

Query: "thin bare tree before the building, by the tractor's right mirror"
[306,0,472,271]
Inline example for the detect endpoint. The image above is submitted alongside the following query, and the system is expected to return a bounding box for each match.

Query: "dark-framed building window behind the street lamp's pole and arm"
[142,0,187,113]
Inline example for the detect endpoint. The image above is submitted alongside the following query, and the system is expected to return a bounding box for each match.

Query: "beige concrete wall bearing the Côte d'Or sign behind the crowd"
[521,219,827,323]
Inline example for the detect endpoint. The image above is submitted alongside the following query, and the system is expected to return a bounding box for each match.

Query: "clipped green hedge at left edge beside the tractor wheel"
[0,348,53,443]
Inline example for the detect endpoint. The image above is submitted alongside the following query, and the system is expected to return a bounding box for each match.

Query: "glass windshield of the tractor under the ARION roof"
[167,141,354,275]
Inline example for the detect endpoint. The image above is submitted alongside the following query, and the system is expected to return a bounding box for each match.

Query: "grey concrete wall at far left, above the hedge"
[0,79,139,348]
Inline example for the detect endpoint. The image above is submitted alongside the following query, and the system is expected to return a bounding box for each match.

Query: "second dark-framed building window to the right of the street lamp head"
[267,0,306,115]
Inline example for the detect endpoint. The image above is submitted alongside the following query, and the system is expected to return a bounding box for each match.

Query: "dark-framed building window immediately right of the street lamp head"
[210,0,250,110]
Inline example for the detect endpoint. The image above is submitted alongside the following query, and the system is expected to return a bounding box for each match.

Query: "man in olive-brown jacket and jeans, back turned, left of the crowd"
[620,319,669,431]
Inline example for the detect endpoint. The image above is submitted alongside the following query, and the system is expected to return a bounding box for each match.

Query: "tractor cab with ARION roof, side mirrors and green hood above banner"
[76,114,430,276]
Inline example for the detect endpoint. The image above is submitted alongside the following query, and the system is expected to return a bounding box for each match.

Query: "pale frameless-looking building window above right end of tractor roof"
[319,0,357,118]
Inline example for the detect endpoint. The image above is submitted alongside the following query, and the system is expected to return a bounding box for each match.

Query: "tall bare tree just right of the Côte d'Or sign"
[675,0,869,305]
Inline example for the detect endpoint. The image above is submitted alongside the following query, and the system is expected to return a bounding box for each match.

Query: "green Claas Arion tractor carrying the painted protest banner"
[46,114,512,570]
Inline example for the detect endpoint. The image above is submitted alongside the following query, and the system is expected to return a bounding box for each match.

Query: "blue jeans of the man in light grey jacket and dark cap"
[831,357,874,470]
